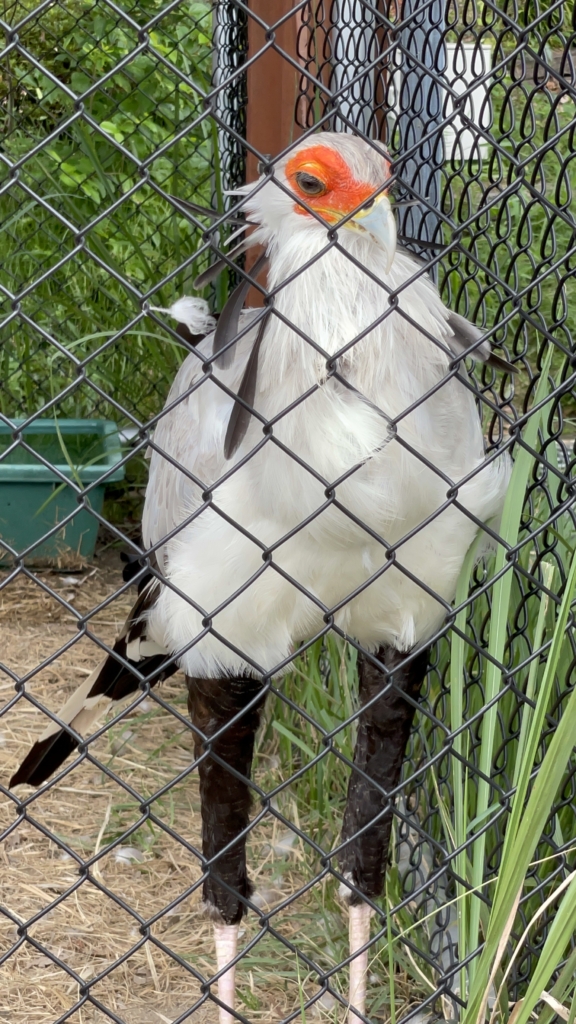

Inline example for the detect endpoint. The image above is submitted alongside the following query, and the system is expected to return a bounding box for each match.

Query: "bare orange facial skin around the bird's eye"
[286,145,375,224]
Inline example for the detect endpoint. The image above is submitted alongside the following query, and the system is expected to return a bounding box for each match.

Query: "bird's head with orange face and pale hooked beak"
[239,132,396,271]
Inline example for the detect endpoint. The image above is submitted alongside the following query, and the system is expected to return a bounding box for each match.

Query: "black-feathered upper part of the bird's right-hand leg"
[340,647,428,904]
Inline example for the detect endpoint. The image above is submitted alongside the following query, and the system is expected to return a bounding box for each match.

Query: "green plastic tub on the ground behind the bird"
[0,419,124,567]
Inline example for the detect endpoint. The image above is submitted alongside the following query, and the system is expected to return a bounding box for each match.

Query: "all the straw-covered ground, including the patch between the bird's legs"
[0,555,410,1024]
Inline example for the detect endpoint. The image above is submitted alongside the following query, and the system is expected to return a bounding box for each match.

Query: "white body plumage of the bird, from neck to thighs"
[145,231,508,677]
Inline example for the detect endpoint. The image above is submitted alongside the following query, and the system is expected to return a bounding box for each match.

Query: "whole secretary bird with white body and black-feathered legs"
[11,132,513,1024]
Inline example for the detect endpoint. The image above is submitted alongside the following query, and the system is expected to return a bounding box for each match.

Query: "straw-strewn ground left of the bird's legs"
[0,567,203,1024]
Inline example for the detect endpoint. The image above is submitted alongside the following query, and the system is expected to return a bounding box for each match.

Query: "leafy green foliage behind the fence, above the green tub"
[0,0,214,421]
